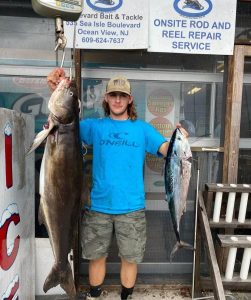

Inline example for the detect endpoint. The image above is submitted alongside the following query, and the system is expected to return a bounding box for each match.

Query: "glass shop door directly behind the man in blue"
[80,68,224,280]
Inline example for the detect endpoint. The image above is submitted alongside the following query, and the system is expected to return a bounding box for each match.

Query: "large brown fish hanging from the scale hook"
[28,79,82,299]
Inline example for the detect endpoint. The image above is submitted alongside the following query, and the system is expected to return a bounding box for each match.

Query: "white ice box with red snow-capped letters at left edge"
[0,108,35,300]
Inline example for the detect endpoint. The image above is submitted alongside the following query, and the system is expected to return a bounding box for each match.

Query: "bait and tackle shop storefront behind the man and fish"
[0,0,251,299]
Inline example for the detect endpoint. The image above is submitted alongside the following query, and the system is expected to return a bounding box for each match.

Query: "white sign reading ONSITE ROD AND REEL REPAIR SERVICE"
[148,0,237,55]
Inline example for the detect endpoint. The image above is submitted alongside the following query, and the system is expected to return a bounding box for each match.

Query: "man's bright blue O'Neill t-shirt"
[80,118,165,214]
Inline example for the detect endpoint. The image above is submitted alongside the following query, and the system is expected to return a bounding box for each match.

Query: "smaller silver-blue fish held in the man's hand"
[165,128,193,260]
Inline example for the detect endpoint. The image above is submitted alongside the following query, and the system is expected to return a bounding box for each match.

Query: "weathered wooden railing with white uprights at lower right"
[195,184,251,299]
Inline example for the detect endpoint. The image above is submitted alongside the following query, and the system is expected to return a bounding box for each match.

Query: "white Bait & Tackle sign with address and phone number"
[64,0,148,49]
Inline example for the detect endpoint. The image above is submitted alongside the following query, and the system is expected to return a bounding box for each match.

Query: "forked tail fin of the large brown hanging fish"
[43,262,76,299]
